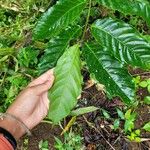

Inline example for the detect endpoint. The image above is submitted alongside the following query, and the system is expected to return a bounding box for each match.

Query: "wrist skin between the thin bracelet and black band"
[0,118,25,140]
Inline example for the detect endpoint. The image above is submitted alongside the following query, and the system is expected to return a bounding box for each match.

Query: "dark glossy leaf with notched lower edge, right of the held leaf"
[83,44,135,104]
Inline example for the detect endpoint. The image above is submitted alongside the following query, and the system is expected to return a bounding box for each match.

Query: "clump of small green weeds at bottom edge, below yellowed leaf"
[54,131,83,150]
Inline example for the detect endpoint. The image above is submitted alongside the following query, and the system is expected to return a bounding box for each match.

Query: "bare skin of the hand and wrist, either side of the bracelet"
[0,70,54,140]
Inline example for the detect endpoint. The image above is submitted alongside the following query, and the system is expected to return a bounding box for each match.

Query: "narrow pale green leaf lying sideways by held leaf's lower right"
[70,106,99,116]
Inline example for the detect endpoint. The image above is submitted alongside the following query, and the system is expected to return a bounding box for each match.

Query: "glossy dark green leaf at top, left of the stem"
[34,0,86,39]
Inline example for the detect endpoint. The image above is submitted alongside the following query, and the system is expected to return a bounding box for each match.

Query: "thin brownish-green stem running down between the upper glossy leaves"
[81,0,92,43]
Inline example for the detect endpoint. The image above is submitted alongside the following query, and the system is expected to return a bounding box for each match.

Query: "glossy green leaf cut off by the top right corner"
[97,0,150,26]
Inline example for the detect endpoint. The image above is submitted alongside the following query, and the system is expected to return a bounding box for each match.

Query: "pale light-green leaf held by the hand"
[48,45,82,123]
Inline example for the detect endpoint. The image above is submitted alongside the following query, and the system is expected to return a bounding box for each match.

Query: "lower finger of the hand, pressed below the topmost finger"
[31,76,54,95]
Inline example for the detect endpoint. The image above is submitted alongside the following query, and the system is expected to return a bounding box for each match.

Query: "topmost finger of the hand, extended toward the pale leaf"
[28,69,54,87]
